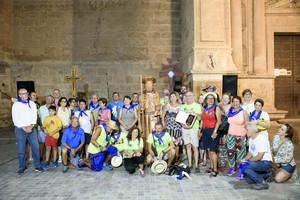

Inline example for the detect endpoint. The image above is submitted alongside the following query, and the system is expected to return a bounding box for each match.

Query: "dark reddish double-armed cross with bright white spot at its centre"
[159,58,183,92]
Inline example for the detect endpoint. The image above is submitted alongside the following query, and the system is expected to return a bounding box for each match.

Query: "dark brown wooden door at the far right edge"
[274,34,300,118]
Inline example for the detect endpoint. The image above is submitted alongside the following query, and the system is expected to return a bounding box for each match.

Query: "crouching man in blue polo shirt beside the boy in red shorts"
[61,116,85,173]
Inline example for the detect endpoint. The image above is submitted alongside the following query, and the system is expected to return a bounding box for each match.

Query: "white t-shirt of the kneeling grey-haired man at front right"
[249,134,272,161]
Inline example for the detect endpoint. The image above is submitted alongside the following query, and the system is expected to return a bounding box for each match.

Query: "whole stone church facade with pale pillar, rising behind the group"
[0,0,300,127]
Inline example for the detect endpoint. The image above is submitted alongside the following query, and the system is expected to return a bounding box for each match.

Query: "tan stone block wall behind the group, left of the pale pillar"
[12,0,181,102]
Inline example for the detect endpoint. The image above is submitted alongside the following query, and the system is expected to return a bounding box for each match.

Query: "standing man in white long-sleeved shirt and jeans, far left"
[12,88,43,174]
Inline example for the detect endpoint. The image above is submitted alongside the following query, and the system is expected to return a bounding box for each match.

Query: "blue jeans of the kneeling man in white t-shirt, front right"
[243,160,272,184]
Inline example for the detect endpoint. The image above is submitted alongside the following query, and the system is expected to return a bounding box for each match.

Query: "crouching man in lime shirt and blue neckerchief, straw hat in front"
[147,122,175,173]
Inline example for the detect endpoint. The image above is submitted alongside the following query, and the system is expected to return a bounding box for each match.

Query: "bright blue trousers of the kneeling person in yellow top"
[89,146,118,172]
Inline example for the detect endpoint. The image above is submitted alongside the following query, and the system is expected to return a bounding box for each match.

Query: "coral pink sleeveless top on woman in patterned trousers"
[228,111,247,137]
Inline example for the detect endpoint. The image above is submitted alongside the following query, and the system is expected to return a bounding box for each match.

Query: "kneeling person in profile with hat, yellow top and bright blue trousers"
[84,120,119,171]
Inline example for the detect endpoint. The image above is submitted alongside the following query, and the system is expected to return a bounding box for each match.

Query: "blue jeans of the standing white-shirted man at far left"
[15,127,41,169]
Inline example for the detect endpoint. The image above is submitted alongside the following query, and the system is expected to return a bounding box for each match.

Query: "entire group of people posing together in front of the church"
[12,81,296,189]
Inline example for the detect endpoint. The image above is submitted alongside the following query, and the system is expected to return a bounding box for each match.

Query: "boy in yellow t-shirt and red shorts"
[43,106,62,167]
